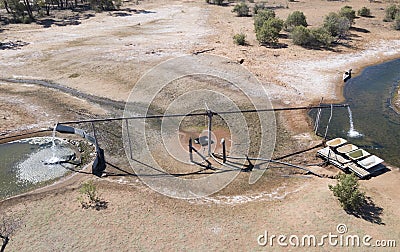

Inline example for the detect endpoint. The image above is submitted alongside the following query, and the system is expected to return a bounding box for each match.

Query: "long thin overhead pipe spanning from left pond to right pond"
[58,104,349,125]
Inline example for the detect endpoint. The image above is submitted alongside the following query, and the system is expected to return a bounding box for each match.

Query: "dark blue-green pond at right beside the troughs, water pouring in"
[310,59,400,166]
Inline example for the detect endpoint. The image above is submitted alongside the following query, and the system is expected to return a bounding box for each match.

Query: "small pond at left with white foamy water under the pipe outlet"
[0,137,75,199]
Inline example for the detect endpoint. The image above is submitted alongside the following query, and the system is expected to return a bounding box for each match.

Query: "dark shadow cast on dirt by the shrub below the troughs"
[346,197,385,225]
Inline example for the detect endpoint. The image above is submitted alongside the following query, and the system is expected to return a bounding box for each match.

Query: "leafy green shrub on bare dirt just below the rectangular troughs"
[329,174,365,211]
